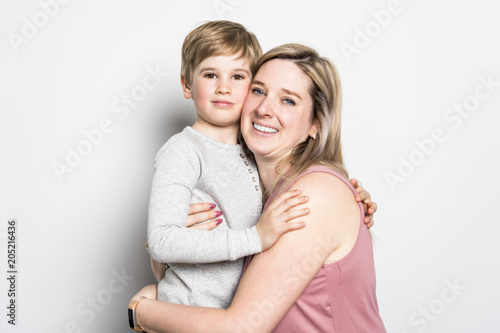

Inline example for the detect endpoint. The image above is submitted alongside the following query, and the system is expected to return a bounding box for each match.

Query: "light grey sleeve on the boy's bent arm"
[147,137,262,264]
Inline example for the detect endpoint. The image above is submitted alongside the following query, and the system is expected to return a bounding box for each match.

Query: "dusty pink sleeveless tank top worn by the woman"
[243,166,386,333]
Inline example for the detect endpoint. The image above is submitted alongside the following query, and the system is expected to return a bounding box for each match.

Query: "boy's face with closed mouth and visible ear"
[181,55,252,127]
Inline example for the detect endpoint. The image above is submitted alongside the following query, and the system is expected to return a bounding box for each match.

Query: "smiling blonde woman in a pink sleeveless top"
[134,44,385,332]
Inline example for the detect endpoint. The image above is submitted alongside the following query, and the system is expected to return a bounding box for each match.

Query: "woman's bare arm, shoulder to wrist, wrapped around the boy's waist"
[137,173,360,332]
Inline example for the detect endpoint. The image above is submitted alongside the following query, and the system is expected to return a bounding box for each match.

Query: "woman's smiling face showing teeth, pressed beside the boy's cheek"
[241,59,316,161]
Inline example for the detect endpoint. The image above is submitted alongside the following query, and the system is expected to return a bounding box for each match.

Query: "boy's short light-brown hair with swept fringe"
[181,21,262,84]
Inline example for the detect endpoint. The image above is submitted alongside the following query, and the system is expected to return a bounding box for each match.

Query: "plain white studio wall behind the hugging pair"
[0,0,500,333]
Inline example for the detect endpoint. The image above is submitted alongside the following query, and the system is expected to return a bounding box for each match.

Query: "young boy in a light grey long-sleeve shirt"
[148,21,304,308]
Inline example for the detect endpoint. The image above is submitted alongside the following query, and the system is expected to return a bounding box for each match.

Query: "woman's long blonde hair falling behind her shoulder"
[257,44,348,199]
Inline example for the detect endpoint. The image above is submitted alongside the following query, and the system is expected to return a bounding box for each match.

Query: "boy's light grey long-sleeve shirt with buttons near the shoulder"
[148,127,262,308]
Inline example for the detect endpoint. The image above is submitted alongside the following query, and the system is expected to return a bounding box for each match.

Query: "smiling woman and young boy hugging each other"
[129,21,385,333]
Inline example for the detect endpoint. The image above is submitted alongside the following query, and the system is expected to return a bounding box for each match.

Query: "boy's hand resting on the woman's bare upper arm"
[256,190,310,251]
